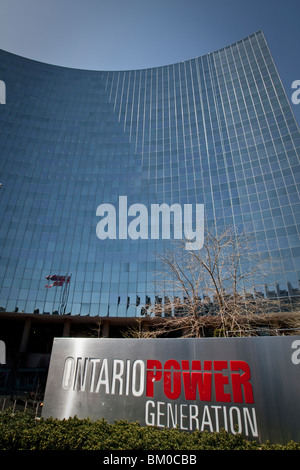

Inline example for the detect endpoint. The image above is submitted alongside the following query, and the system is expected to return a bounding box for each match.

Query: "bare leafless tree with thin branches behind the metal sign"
[140,227,300,337]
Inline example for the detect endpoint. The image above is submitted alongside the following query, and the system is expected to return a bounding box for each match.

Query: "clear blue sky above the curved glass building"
[0,0,300,123]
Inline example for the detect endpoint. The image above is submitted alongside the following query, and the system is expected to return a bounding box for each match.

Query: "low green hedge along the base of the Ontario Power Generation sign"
[0,409,300,451]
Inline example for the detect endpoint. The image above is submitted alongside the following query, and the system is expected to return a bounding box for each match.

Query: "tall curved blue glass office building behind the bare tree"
[0,32,300,317]
